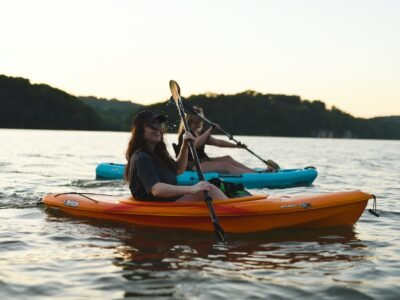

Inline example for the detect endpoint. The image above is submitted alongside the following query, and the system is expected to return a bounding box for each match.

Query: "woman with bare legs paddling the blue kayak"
[177,106,272,175]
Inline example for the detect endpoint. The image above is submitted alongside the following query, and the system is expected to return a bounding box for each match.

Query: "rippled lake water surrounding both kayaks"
[0,130,400,299]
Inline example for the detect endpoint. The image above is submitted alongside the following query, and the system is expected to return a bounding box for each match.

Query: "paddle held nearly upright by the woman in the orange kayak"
[169,80,226,242]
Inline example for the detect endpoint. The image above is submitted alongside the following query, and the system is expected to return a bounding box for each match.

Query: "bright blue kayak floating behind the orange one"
[96,163,318,189]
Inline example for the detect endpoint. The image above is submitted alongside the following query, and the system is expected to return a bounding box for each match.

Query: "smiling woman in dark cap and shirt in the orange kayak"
[125,111,227,201]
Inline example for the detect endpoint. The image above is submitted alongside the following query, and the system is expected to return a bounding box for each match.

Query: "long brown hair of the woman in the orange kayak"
[125,119,178,182]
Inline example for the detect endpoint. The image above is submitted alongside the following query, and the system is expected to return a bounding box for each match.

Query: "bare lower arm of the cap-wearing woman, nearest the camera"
[151,181,211,198]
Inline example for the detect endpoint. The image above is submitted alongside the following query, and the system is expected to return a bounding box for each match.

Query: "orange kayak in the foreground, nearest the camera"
[43,191,373,233]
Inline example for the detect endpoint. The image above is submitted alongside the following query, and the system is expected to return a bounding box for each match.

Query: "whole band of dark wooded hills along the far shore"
[0,76,400,139]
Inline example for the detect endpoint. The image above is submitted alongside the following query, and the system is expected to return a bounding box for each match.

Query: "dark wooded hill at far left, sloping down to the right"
[0,75,105,130]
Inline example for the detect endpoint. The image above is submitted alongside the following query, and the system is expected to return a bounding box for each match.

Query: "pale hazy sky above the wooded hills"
[0,0,400,117]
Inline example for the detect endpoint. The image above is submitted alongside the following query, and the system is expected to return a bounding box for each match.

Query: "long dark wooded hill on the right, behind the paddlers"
[148,91,400,139]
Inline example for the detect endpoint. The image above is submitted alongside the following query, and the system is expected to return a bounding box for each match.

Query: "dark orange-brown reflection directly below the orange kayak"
[111,228,367,276]
